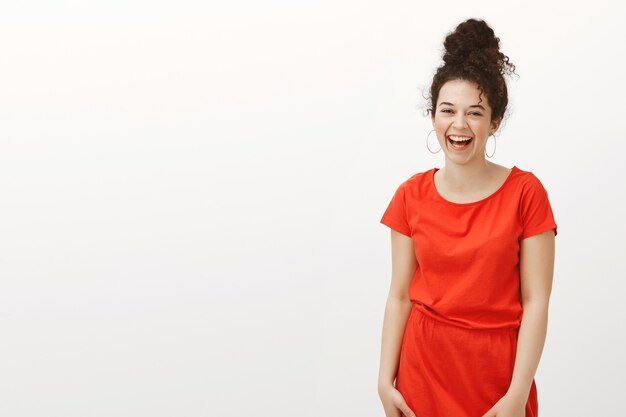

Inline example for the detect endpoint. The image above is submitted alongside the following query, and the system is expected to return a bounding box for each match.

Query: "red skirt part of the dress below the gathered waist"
[396,304,538,417]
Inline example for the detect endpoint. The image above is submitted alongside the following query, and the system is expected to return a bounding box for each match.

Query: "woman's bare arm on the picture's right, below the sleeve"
[507,230,555,403]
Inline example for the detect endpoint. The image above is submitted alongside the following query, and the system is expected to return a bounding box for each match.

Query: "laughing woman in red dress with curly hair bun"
[378,19,557,417]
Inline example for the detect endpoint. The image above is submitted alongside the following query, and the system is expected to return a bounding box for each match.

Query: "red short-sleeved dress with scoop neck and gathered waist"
[381,166,557,417]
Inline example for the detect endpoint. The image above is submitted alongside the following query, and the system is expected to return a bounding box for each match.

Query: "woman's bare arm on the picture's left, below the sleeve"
[378,229,417,392]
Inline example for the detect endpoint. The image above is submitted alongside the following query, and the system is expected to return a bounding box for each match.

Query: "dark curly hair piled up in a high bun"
[427,19,515,128]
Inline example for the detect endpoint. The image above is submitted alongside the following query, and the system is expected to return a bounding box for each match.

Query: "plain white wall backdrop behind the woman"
[0,0,626,417]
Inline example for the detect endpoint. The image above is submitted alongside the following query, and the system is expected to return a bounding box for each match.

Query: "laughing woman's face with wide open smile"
[432,80,499,165]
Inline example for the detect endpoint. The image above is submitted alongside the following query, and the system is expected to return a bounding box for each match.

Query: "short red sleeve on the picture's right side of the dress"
[520,175,557,239]
